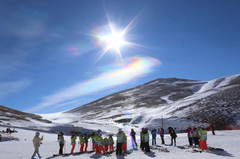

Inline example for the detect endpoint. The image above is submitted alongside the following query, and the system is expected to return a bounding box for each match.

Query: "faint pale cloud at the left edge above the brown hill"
[0,79,32,100]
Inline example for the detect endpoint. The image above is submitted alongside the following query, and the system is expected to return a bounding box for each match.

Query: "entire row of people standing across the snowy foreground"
[30,126,214,159]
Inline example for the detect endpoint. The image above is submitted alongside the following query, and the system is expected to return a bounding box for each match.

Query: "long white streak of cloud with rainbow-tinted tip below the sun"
[26,57,161,112]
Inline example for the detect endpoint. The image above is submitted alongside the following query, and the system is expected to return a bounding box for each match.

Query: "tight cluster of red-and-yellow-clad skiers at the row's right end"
[187,126,207,151]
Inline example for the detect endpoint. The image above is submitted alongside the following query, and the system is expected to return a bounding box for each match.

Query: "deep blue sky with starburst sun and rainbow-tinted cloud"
[0,0,240,113]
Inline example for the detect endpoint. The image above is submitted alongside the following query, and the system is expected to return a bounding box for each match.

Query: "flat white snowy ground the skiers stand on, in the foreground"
[0,127,240,159]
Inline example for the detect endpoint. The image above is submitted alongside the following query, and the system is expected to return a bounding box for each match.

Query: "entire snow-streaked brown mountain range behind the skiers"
[0,74,240,132]
